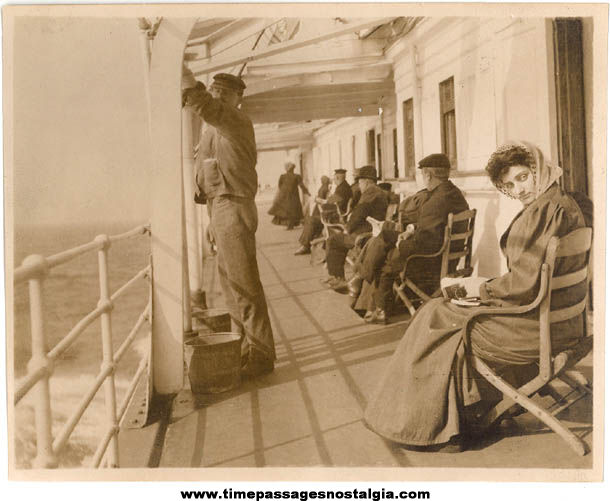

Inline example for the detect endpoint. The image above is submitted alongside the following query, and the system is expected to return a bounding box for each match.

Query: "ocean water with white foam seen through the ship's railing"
[13,223,150,468]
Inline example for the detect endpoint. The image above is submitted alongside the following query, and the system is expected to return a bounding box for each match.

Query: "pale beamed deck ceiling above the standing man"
[185,17,418,149]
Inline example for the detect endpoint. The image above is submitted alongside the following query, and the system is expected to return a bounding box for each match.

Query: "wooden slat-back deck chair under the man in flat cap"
[393,209,477,315]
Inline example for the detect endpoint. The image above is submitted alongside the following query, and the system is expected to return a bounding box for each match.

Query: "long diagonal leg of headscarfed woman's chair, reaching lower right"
[473,358,587,456]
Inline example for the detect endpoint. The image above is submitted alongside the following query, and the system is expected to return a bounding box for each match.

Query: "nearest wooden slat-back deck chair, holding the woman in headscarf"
[464,228,593,456]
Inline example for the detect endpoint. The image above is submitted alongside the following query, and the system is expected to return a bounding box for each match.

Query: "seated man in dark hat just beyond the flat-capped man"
[325,165,388,290]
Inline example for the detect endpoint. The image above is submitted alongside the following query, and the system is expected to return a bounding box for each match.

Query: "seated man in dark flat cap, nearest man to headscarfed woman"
[360,153,469,323]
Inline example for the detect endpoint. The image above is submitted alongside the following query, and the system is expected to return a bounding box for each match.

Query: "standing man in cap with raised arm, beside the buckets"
[182,73,275,377]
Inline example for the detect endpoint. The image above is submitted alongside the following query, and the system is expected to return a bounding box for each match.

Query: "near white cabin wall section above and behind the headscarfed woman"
[389,18,556,276]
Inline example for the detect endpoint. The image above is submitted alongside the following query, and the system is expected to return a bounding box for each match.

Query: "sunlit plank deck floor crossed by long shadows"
[121,199,592,468]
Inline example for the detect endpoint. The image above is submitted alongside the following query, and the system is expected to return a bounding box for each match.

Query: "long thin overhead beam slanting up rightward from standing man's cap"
[193,17,393,75]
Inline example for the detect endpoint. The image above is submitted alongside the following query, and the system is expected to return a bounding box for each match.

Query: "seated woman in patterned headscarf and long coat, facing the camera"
[365,142,586,452]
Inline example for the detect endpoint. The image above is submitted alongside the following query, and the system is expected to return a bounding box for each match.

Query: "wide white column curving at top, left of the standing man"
[150,18,194,394]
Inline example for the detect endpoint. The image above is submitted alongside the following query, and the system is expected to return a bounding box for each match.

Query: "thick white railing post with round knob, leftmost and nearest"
[23,255,57,468]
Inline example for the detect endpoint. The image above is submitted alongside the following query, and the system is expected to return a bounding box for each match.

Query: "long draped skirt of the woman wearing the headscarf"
[365,298,582,445]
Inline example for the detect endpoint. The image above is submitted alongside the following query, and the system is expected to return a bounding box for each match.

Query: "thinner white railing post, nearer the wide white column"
[95,235,119,468]
